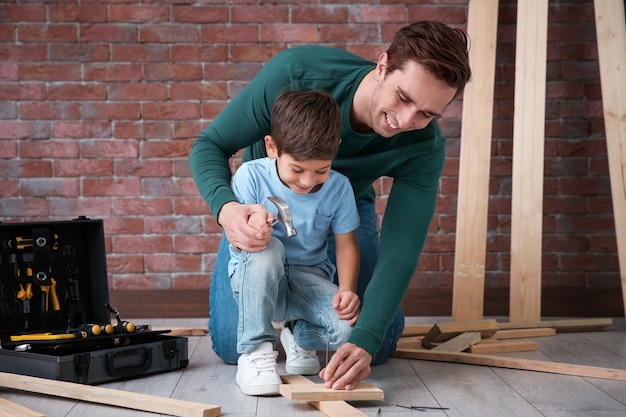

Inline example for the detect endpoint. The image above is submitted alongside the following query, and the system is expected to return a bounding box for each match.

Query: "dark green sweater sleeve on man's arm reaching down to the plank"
[350,140,445,357]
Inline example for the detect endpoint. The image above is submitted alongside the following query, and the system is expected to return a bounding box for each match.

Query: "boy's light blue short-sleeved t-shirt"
[228,158,359,276]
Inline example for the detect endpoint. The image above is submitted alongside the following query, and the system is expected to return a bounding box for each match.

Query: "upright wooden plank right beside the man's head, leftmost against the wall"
[452,0,498,320]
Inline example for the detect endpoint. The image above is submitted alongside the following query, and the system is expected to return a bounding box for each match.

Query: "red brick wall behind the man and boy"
[0,0,619,306]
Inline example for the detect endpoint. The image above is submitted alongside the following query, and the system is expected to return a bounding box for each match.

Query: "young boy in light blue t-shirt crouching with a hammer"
[228,90,361,395]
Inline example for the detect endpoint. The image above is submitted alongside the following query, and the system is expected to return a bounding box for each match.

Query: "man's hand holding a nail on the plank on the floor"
[319,343,372,391]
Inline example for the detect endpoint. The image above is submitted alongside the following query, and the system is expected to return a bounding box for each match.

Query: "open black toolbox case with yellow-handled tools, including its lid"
[0,217,189,384]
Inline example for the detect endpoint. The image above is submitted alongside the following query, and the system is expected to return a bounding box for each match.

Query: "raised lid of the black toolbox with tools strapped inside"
[0,217,111,342]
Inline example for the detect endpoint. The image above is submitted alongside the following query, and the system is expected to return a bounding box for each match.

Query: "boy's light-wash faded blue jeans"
[231,237,352,353]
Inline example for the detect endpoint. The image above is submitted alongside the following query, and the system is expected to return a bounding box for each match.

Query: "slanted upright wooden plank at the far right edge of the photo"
[594,0,626,314]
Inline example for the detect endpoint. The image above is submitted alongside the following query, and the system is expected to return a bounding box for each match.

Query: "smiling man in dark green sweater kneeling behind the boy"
[190,21,471,390]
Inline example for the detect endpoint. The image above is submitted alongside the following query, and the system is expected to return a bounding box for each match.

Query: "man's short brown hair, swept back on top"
[387,21,472,96]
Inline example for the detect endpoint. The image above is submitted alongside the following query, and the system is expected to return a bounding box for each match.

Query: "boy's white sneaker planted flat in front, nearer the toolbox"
[237,342,282,395]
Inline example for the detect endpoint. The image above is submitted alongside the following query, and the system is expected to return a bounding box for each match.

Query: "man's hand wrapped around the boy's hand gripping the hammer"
[218,201,272,252]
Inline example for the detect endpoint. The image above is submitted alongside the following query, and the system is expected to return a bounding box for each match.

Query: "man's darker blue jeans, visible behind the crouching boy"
[209,200,404,364]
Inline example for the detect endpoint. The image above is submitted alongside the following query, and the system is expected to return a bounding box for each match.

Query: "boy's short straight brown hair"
[271,90,341,161]
